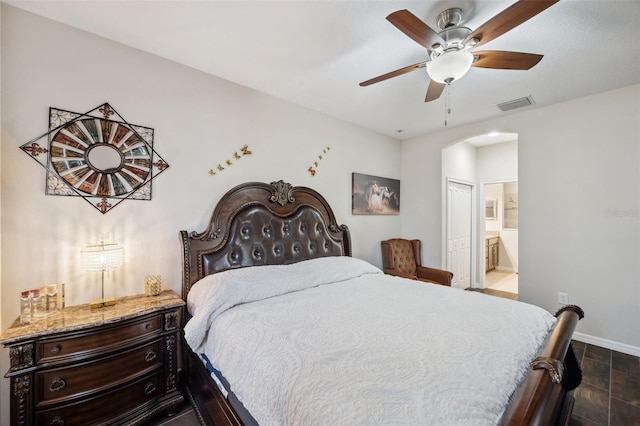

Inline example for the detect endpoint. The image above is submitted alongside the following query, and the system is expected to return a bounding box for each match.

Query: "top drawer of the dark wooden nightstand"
[36,315,162,362]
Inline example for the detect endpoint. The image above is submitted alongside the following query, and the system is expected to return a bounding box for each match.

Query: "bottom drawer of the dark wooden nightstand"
[35,371,164,426]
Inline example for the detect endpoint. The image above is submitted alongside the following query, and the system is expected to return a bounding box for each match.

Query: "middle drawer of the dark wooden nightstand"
[35,339,164,408]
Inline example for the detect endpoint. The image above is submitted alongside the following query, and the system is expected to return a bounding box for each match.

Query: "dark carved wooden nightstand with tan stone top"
[0,290,184,426]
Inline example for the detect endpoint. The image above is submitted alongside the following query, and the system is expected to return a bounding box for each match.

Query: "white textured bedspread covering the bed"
[185,257,555,426]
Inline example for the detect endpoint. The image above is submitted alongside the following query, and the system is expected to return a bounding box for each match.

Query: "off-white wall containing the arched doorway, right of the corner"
[402,85,640,354]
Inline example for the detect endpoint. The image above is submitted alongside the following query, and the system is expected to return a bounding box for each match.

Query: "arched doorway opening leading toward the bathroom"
[442,133,520,298]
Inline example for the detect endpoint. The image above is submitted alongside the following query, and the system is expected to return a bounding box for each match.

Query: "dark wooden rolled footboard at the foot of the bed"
[500,305,584,426]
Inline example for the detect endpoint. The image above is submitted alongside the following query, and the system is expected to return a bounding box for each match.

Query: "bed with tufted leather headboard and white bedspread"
[180,181,584,425]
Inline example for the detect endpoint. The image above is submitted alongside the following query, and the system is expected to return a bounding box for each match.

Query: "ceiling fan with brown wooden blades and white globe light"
[360,0,560,102]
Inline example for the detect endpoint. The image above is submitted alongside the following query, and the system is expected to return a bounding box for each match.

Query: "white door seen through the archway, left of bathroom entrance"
[447,181,473,289]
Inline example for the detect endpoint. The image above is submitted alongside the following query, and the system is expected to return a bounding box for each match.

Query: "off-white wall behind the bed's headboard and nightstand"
[0,4,404,424]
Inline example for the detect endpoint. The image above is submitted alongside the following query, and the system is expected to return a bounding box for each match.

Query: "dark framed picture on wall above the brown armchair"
[351,173,400,215]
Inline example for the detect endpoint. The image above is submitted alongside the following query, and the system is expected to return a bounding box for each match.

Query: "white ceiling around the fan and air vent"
[4,0,640,139]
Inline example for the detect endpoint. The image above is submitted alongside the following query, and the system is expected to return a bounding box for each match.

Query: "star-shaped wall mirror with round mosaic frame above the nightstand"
[20,103,169,214]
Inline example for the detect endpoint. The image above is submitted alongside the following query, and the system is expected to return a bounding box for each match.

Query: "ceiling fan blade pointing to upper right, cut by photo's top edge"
[464,0,560,47]
